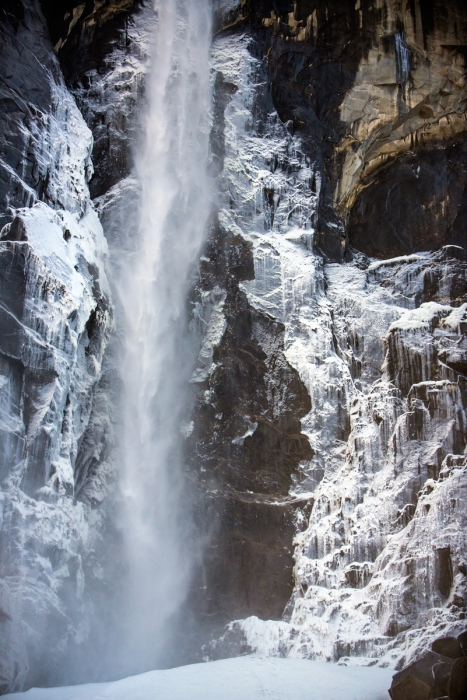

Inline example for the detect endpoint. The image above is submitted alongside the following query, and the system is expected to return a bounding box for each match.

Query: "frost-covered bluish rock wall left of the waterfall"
[0,3,112,692]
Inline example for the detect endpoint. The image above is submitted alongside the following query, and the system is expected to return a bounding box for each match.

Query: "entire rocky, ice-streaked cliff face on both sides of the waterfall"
[0,0,467,689]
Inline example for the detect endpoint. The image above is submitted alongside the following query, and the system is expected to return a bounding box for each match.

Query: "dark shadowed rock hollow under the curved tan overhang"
[349,141,467,258]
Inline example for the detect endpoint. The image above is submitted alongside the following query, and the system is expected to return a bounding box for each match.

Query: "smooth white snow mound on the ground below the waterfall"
[5,656,392,700]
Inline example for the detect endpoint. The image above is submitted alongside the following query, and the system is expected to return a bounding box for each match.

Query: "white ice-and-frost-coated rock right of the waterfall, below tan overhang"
[213,35,467,666]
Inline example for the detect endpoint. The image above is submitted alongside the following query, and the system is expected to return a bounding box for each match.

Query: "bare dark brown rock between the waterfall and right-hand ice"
[187,219,311,640]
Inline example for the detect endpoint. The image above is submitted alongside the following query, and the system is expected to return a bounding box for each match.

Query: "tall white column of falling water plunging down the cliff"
[115,0,211,672]
